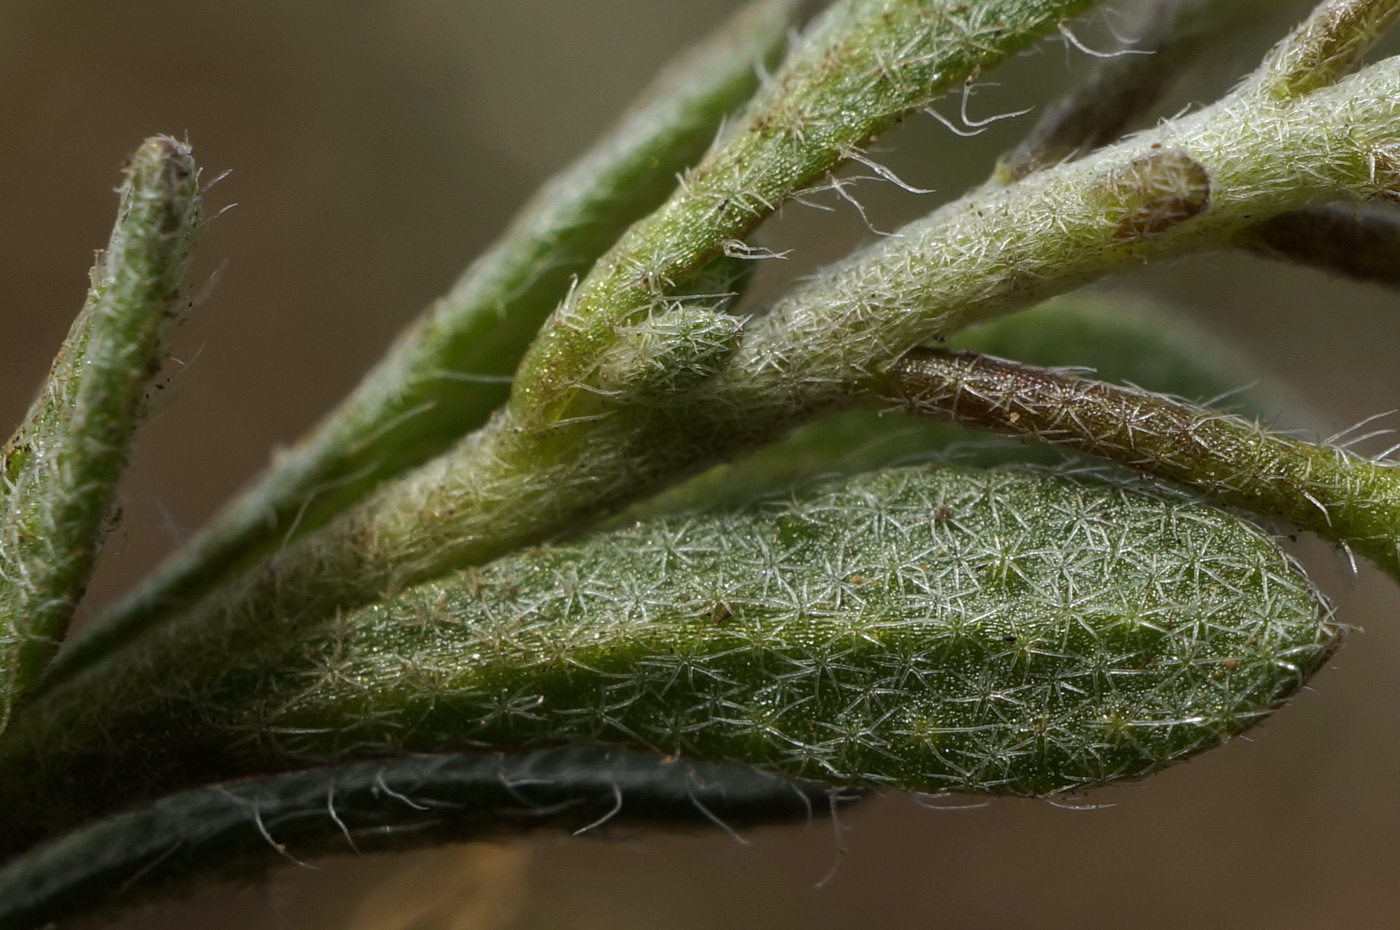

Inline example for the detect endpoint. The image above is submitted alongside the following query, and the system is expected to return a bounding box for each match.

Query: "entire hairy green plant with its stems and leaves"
[0,0,1400,927]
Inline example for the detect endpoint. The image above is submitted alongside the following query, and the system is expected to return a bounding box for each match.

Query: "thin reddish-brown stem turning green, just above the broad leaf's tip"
[882,349,1400,580]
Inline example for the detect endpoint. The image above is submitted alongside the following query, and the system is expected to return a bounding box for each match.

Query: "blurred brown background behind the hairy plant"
[0,0,1400,930]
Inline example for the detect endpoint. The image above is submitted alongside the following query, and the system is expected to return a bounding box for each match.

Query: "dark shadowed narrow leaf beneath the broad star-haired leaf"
[0,747,829,930]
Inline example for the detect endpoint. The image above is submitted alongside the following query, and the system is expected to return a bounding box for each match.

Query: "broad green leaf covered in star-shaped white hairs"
[0,468,1338,847]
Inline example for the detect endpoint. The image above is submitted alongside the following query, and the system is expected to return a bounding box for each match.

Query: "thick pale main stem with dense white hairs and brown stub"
[32,45,1400,717]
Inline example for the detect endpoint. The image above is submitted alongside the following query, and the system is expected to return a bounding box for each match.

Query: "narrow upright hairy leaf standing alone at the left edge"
[0,136,203,730]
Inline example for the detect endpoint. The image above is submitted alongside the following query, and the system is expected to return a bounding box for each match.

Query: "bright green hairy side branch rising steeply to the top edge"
[511,0,1099,426]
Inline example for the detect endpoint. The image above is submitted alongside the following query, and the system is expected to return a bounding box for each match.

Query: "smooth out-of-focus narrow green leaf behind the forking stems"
[95,0,798,652]
